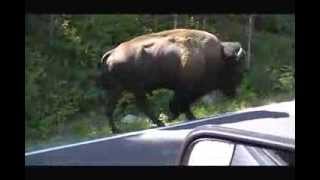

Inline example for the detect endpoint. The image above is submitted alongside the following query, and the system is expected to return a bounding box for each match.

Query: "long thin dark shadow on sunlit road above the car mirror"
[166,111,289,130]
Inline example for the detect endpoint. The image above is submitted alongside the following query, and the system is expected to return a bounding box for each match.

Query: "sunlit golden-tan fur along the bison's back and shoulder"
[122,29,220,76]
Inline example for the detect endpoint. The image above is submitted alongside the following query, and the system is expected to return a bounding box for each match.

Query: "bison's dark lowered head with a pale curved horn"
[220,42,246,97]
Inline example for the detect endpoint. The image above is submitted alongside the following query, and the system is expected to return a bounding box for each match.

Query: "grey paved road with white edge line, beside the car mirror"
[25,101,295,166]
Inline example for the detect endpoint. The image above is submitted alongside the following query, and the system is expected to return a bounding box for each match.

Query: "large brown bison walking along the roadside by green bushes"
[97,29,245,132]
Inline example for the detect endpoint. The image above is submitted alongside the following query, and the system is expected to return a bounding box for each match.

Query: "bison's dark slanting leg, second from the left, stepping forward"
[134,92,165,127]
